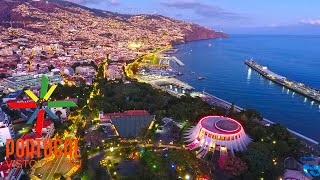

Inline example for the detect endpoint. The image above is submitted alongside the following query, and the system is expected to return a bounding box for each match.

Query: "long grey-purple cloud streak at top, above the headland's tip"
[161,0,244,18]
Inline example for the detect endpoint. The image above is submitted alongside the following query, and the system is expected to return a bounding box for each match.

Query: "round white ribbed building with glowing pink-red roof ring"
[184,116,252,158]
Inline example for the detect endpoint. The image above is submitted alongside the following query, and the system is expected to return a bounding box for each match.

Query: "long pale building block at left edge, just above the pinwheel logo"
[2,73,63,92]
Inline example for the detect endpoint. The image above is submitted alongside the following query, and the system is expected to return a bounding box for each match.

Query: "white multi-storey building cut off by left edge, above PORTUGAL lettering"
[0,108,15,147]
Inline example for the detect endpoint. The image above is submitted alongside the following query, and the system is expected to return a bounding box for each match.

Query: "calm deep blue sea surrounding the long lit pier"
[174,35,320,141]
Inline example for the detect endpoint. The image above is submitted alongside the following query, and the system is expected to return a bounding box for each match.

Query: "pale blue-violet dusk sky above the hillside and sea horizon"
[69,0,320,34]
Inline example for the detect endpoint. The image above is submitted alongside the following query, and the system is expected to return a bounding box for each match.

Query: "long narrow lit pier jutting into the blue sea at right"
[245,60,320,102]
